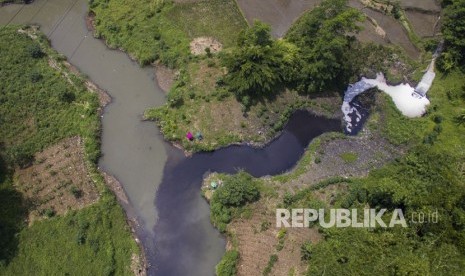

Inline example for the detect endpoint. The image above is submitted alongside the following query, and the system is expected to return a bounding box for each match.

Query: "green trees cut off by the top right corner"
[438,0,465,71]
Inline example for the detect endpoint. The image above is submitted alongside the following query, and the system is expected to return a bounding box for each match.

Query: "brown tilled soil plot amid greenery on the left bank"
[14,137,99,224]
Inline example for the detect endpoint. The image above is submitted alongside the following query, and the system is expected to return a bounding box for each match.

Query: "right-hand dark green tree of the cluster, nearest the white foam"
[286,0,364,92]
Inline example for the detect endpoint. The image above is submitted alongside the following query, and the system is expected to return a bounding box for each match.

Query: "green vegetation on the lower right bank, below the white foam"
[299,72,465,275]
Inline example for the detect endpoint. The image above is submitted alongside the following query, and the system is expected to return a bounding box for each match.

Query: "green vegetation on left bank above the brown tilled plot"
[0,27,100,167]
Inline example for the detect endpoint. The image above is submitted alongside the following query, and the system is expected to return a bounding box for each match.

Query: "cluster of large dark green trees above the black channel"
[224,0,364,99]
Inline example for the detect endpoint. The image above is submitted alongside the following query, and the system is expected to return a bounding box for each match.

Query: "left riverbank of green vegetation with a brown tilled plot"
[0,25,145,275]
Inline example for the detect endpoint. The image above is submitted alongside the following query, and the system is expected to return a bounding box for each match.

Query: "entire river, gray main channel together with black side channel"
[0,0,340,276]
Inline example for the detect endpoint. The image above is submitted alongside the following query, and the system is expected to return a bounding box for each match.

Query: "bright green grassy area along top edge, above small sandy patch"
[90,0,247,67]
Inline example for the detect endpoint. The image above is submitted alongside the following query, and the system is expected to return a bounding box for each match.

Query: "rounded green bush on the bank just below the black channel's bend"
[210,172,260,232]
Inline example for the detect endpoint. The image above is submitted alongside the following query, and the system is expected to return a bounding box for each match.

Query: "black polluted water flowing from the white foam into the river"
[149,111,341,276]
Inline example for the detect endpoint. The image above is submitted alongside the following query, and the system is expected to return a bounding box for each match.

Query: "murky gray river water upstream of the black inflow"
[0,0,167,242]
